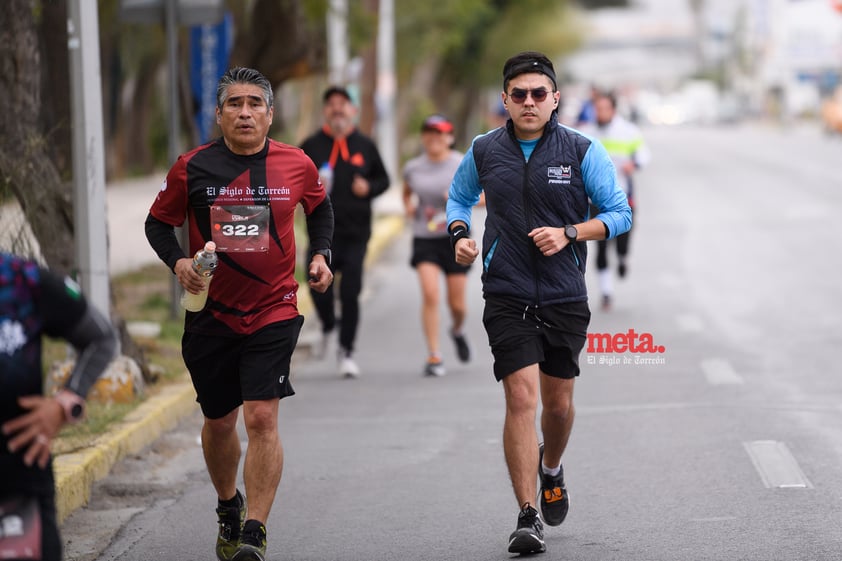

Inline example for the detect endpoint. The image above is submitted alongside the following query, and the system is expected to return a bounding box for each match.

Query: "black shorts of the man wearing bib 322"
[181,316,304,419]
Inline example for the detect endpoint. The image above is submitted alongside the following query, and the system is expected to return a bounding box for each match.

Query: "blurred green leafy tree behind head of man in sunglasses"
[397,0,580,147]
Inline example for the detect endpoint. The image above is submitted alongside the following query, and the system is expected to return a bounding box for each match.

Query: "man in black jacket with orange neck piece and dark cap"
[301,86,389,378]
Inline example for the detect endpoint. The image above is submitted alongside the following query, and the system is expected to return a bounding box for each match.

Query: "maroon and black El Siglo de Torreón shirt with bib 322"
[146,138,333,335]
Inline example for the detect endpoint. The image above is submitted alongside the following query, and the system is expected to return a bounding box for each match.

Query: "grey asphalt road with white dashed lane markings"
[63,123,842,561]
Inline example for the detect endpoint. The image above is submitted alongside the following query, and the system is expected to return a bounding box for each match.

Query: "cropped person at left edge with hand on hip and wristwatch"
[0,252,118,561]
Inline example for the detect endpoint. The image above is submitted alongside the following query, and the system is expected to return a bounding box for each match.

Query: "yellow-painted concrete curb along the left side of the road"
[53,215,404,524]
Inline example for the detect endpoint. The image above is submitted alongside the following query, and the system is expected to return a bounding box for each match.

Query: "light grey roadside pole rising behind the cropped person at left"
[67,0,111,317]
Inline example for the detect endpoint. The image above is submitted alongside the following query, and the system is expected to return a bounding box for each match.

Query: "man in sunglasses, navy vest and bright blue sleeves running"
[447,52,631,554]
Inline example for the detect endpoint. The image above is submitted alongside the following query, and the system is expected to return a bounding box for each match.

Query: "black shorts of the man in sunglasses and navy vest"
[482,295,591,382]
